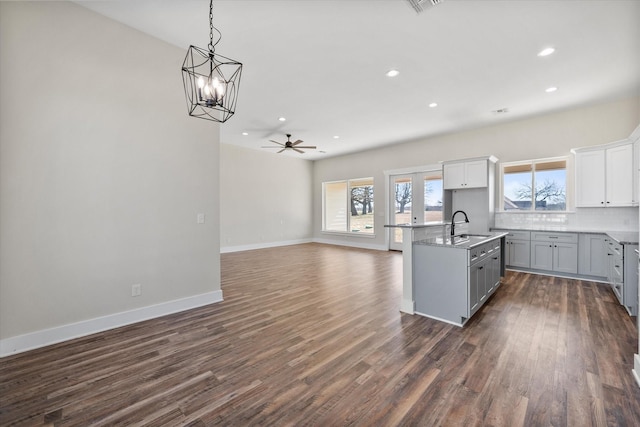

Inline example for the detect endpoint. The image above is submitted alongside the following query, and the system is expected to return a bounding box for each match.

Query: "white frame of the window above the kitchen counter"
[496,156,574,214]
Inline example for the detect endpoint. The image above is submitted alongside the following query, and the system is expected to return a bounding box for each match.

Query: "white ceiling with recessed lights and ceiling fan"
[77,0,640,159]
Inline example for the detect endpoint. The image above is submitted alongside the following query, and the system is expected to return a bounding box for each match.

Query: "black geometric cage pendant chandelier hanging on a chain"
[182,0,242,123]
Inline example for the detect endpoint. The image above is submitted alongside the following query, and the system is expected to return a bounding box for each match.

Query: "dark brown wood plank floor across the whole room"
[0,244,640,426]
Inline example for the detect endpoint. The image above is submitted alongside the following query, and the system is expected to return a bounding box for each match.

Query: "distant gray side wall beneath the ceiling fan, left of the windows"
[220,144,313,252]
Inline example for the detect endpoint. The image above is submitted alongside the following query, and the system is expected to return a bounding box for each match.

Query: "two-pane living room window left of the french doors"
[322,178,374,234]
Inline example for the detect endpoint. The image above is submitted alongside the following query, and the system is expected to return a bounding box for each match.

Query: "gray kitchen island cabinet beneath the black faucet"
[412,233,506,326]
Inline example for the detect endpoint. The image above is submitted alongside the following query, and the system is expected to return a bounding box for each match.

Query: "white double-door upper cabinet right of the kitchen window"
[573,141,637,208]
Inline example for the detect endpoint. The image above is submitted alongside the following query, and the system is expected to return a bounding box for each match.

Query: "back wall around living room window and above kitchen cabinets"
[313,96,640,249]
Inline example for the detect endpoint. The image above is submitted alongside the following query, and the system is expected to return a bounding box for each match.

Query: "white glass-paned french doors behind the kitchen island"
[389,169,443,251]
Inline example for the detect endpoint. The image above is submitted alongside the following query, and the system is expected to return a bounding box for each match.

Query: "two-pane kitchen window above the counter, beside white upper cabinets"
[502,158,567,212]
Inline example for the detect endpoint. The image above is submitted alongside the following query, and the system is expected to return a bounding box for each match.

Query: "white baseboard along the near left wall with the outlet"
[0,290,222,357]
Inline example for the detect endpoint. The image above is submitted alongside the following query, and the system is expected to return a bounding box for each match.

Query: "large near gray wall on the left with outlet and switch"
[0,2,220,348]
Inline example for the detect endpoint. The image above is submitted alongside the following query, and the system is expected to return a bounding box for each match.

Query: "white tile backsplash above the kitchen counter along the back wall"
[495,207,638,231]
